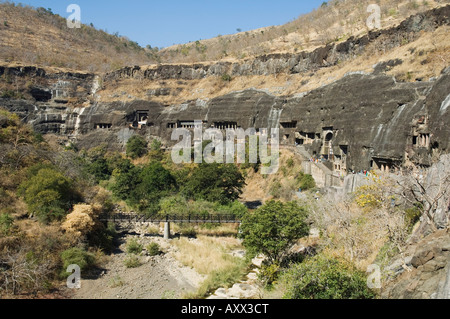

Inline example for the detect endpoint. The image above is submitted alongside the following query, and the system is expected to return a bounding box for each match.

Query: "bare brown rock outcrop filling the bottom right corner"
[382,230,450,299]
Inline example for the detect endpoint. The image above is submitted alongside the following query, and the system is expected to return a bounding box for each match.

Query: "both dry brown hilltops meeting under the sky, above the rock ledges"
[0,0,449,73]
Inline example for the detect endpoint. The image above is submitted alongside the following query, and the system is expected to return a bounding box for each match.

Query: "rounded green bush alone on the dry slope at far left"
[19,168,80,223]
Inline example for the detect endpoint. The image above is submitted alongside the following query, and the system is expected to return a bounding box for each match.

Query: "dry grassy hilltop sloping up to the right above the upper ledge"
[160,0,449,63]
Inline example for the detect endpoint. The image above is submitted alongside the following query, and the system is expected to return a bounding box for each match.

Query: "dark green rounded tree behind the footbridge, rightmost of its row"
[184,163,245,204]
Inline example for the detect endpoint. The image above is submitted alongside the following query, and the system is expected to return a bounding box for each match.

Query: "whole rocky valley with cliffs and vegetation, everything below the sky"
[0,0,450,299]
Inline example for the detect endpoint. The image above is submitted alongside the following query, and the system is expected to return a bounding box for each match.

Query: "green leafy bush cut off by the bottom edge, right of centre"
[281,255,376,299]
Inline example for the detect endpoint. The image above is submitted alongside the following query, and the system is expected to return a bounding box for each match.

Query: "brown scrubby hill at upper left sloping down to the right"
[0,3,155,72]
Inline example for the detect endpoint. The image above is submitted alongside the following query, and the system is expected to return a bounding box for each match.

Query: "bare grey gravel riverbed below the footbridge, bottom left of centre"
[72,226,205,299]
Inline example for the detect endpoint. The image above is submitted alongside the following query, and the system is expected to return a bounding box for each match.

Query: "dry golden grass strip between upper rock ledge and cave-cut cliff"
[99,22,450,105]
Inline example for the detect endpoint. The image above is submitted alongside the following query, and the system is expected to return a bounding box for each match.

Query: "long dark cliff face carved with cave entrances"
[4,72,450,175]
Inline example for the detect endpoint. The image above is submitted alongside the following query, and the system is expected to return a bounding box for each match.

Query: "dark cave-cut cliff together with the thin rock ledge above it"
[0,6,450,177]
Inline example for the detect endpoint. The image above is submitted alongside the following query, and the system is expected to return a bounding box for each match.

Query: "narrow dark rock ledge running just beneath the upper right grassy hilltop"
[105,6,450,81]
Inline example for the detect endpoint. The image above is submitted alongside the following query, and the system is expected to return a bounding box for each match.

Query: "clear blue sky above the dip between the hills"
[14,0,324,48]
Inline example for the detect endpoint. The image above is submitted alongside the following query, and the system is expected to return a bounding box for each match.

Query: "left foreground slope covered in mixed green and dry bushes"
[0,110,114,296]
